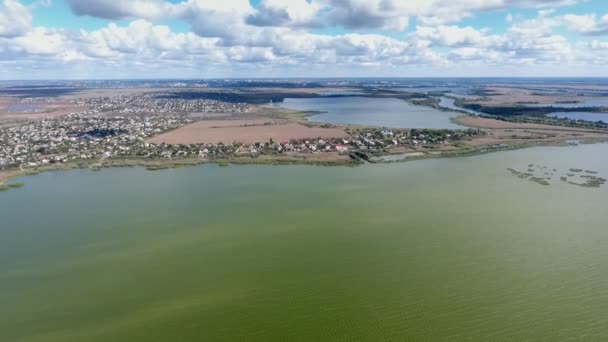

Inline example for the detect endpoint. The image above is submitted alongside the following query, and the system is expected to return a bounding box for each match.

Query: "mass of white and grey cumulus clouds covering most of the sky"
[0,0,608,76]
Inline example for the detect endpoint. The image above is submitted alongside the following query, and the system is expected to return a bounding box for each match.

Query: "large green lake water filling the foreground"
[0,145,608,342]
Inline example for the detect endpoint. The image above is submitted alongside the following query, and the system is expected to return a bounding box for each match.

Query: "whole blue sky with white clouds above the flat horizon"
[0,0,608,80]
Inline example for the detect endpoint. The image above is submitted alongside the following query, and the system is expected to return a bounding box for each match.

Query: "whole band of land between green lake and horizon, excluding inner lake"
[0,80,608,176]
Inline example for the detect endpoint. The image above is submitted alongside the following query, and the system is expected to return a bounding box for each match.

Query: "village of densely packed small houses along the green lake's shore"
[0,95,483,170]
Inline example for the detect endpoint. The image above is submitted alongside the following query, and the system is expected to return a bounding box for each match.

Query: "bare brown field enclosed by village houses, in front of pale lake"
[148,119,348,145]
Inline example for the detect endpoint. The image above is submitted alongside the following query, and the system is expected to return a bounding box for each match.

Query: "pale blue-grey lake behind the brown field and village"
[278,97,465,129]
